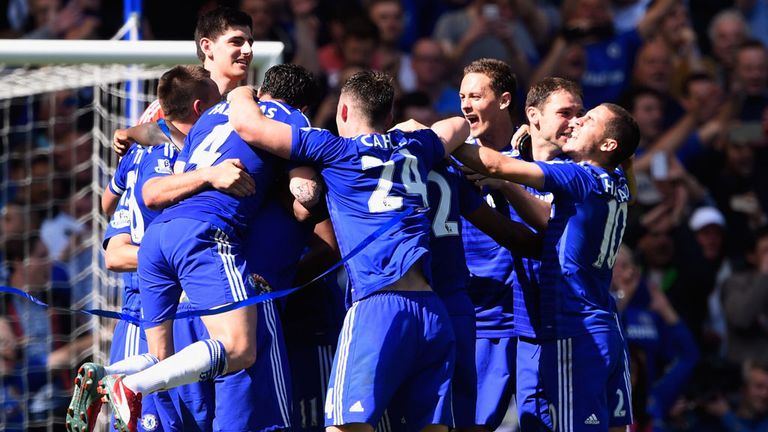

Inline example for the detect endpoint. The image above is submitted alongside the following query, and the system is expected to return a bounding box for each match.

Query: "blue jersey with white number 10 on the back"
[536,161,630,338]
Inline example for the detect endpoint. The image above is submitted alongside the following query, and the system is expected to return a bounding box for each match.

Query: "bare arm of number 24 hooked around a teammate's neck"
[227,86,293,159]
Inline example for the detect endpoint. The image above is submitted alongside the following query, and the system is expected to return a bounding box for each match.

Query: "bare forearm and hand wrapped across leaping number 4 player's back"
[142,159,256,210]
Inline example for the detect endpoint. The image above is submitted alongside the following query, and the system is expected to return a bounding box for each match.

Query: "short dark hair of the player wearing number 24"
[341,70,395,126]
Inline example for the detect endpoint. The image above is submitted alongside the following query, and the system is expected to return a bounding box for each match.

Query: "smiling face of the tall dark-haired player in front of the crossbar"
[200,26,253,89]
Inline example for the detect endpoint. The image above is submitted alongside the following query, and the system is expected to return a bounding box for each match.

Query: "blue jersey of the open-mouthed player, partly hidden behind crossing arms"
[461,138,517,338]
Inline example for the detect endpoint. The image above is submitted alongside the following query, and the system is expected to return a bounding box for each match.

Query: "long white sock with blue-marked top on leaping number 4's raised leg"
[123,339,227,395]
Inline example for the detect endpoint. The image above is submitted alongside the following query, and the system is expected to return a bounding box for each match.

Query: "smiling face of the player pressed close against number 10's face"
[526,90,584,148]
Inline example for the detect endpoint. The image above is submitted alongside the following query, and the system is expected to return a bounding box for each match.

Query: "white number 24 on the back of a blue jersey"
[360,149,427,213]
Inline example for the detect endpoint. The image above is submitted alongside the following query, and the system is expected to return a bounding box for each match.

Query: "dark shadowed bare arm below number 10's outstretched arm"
[462,202,542,258]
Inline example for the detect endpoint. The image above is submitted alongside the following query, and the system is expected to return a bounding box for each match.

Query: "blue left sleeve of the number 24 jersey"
[291,126,347,165]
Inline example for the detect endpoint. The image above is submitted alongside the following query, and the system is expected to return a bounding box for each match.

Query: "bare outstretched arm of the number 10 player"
[453,144,544,189]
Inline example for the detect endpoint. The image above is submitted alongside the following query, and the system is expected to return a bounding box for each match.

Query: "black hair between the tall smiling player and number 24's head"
[261,64,319,109]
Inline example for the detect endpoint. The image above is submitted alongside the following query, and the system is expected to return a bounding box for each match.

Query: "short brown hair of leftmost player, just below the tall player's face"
[157,65,212,120]
